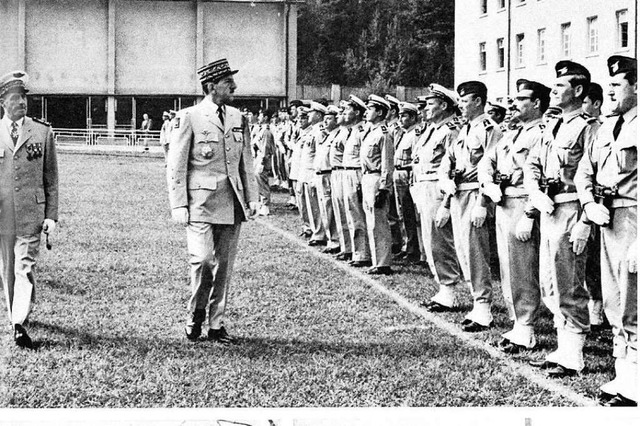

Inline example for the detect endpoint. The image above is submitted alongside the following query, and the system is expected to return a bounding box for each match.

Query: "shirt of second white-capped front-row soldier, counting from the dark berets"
[360,123,393,191]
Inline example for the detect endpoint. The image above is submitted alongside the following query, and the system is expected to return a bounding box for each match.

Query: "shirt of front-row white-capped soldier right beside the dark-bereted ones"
[412,115,460,179]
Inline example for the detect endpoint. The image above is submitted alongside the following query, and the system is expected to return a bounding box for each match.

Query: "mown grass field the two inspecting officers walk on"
[0,154,613,408]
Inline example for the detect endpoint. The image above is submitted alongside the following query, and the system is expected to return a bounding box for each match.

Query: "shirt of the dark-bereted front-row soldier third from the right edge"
[478,119,544,188]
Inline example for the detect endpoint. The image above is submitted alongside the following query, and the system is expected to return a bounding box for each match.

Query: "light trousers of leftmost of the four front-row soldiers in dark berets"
[451,189,493,304]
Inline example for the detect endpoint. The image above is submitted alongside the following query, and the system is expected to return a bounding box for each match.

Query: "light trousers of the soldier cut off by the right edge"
[600,206,638,364]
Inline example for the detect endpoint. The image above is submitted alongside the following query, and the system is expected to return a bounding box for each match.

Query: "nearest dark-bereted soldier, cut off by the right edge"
[575,55,638,407]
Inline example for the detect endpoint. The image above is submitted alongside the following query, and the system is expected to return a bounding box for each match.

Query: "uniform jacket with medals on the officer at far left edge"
[0,117,58,235]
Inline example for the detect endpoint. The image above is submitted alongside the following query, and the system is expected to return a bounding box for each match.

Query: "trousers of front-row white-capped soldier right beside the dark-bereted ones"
[411,181,462,286]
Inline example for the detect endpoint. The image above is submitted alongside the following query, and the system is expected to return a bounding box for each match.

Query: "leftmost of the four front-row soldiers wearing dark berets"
[438,81,502,332]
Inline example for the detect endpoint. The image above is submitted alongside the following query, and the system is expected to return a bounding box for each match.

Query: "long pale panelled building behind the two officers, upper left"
[0,0,300,130]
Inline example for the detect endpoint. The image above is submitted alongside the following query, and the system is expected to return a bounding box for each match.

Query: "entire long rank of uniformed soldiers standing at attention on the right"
[253,56,638,406]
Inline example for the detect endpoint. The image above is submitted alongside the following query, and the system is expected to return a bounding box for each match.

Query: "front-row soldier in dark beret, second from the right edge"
[524,61,597,377]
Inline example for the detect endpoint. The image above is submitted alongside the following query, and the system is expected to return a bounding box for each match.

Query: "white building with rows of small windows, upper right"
[455,0,638,105]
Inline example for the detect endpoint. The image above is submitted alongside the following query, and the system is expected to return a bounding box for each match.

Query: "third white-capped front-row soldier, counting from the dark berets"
[342,95,371,268]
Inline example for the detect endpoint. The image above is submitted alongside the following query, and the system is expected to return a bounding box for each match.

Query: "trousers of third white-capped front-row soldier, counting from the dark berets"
[342,170,371,260]
